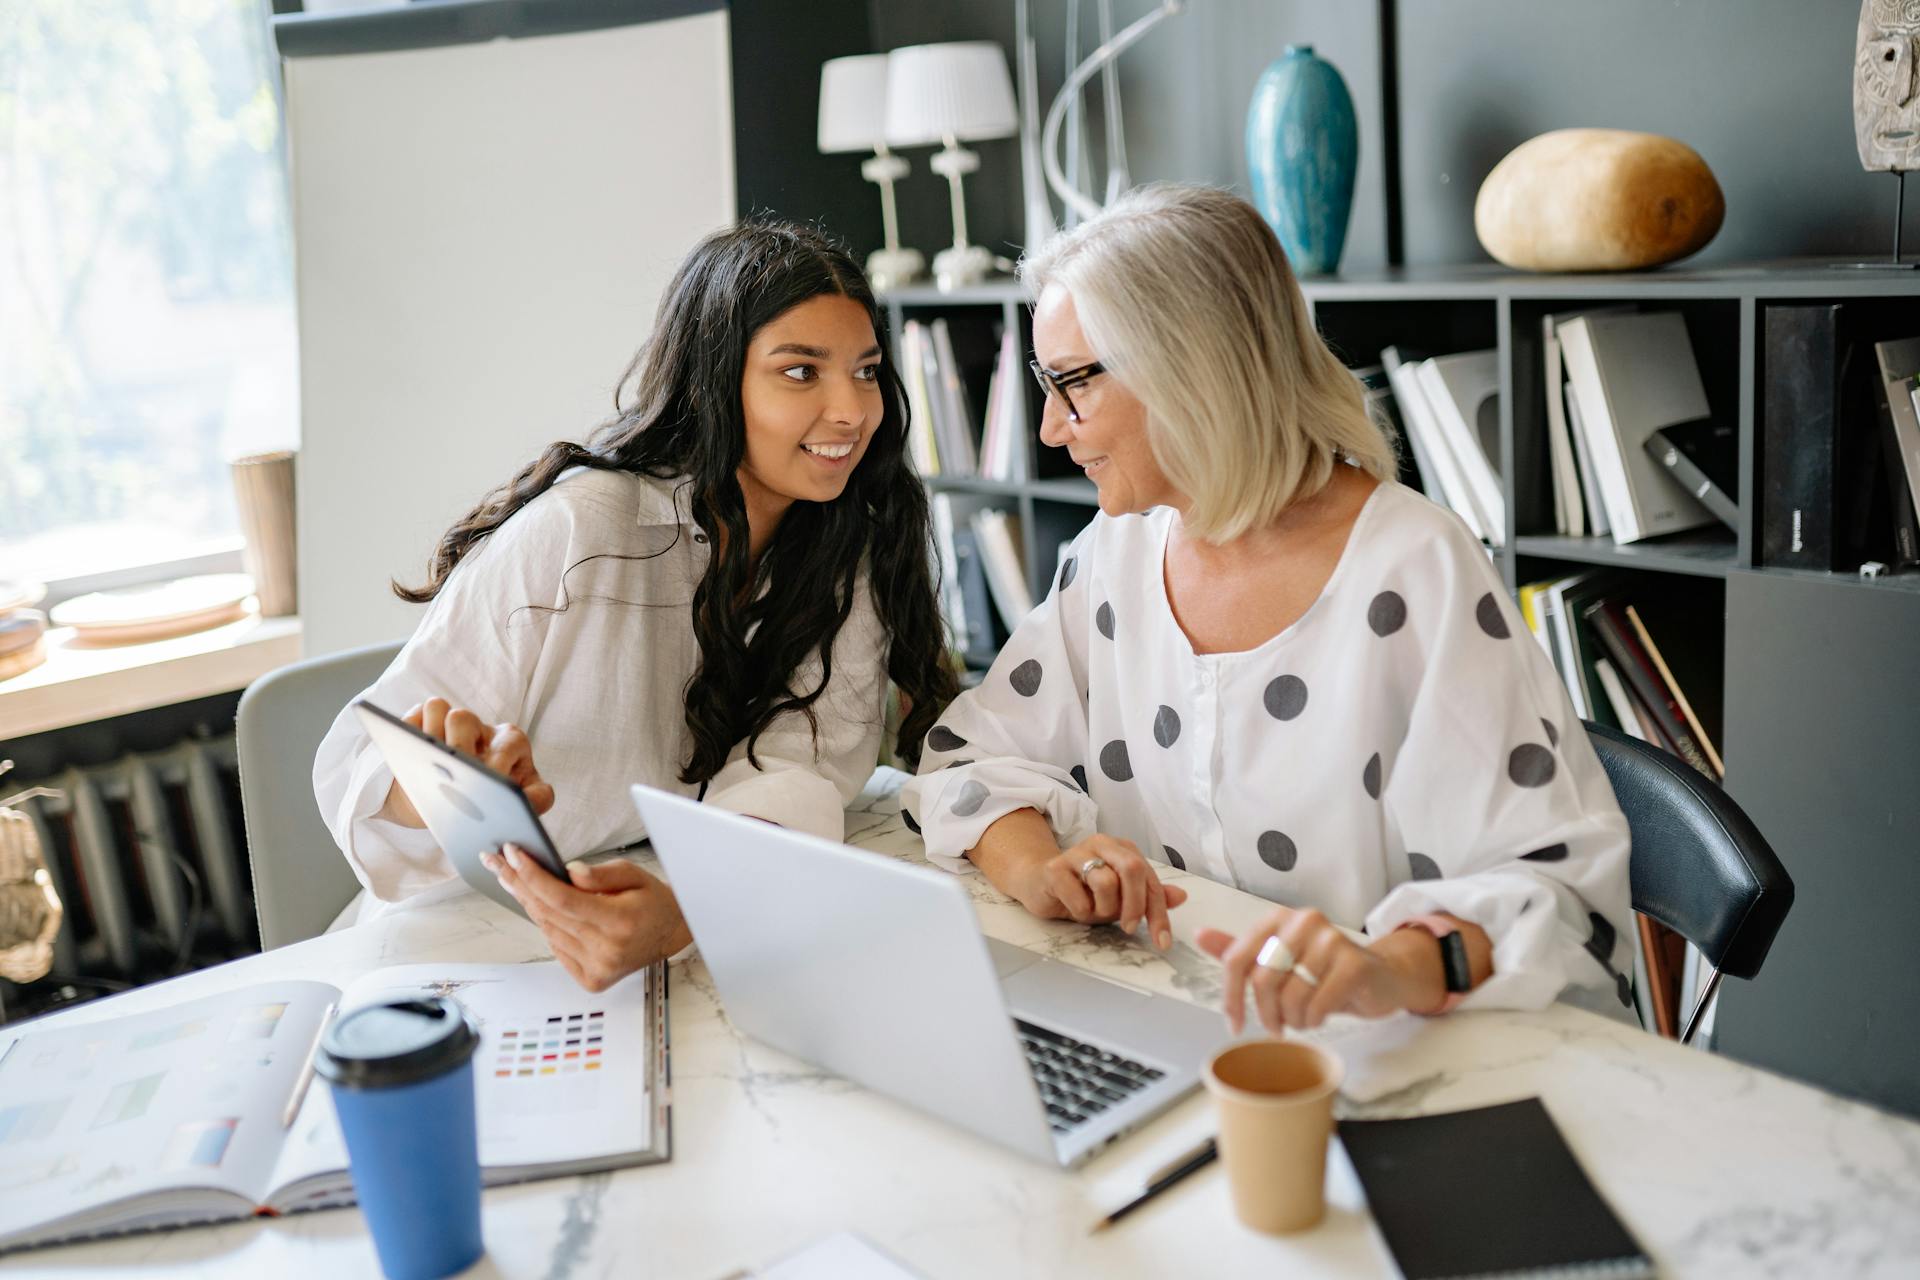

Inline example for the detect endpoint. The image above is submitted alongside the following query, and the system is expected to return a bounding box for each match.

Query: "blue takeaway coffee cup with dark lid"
[313,998,486,1280]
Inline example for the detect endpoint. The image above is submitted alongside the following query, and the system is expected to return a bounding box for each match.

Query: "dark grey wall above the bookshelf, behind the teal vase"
[870,0,1920,271]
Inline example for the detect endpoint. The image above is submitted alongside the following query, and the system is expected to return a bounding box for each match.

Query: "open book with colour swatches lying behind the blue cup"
[0,961,672,1251]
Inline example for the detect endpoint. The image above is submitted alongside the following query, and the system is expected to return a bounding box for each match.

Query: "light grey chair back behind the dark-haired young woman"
[234,643,399,950]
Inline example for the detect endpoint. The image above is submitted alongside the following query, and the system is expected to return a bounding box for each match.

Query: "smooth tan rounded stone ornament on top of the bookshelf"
[1473,129,1726,271]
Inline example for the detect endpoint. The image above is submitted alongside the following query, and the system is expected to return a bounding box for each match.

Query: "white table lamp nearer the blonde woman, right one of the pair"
[887,40,1020,290]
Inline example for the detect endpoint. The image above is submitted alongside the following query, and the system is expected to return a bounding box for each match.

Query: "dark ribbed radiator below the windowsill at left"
[21,733,259,983]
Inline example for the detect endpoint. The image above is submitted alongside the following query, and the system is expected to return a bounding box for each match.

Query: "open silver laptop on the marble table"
[634,787,1229,1165]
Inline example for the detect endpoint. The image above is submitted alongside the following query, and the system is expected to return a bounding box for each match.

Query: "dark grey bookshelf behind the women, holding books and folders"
[885,259,1920,1115]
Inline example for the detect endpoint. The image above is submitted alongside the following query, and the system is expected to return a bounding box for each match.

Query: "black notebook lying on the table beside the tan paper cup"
[1338,1098,1653,1280]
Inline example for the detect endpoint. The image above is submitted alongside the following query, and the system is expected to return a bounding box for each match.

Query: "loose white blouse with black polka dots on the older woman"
[902,484,1632,1007]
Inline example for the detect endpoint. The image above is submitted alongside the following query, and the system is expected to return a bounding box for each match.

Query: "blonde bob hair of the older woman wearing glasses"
[1020,182,1398,543]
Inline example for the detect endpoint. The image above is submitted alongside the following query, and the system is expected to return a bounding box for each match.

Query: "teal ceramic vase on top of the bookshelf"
[1246,44,1359,274]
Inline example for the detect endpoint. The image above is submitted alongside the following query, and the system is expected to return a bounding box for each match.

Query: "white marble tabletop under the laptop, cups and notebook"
[11,775,1920,1280]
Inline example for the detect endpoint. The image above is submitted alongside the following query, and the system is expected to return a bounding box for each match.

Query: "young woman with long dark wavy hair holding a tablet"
[315,223,954,990]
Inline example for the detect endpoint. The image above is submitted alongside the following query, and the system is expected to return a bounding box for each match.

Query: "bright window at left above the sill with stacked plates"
[0,0,298,580]
